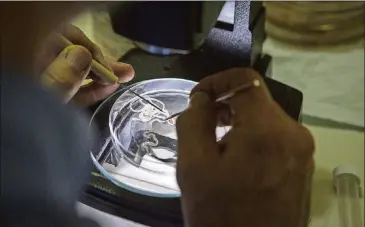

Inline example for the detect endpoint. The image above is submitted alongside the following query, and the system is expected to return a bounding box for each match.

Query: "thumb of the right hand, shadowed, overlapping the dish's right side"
[176,92,218,162]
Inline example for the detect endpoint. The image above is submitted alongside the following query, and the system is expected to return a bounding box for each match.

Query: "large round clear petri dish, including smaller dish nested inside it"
[90,78,228,197]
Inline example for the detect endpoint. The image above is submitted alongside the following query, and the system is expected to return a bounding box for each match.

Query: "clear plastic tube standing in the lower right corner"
[334,166,364,227]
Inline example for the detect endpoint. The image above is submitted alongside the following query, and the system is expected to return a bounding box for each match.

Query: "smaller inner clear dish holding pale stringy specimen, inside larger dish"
[109,79,192,174]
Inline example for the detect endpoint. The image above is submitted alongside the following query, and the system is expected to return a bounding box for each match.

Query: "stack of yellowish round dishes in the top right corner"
[264,1,365,46]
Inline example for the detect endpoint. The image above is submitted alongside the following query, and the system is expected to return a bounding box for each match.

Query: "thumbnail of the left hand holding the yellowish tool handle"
[65,46,92,73]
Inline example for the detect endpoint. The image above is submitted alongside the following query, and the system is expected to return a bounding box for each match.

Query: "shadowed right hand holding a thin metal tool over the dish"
[176,69,314,227]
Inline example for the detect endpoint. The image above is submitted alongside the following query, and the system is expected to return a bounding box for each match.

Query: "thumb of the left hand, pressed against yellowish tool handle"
[41,45,92,102]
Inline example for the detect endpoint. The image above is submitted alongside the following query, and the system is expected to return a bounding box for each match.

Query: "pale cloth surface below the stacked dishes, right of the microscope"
[263,39,364,127]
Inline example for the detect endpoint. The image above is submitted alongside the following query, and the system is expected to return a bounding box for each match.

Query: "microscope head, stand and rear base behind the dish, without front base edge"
[104,1,302,120]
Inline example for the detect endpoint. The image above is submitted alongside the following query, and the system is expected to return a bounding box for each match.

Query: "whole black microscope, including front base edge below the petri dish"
[84,1,303,227]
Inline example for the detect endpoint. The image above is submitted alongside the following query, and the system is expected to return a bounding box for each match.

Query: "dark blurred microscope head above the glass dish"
[109,1,224,51]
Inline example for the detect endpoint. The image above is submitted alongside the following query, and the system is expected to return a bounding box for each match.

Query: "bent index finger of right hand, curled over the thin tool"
[191,68,272,123]
